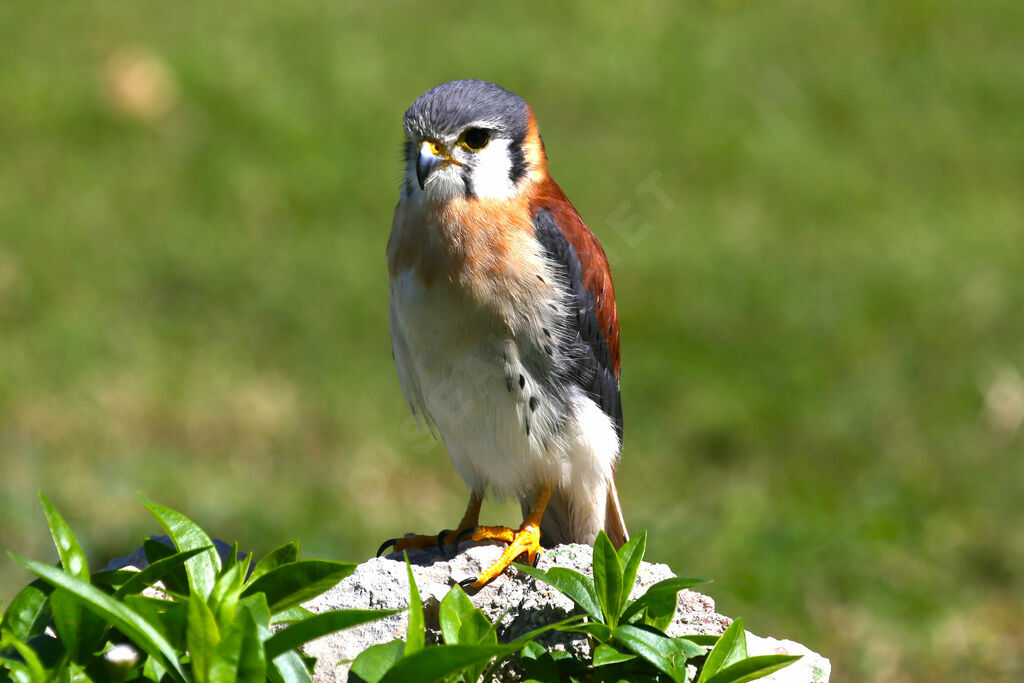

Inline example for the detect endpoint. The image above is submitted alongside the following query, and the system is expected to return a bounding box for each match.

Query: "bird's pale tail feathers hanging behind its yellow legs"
[522,476,630,548]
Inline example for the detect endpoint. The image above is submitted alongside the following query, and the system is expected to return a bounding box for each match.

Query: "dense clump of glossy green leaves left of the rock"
[0,496,396,683]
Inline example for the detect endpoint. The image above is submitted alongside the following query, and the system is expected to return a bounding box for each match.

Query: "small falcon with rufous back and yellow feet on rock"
[378,79,629,589]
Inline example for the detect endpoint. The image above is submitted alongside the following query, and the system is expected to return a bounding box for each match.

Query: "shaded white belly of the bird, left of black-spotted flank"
[391,271,565,498]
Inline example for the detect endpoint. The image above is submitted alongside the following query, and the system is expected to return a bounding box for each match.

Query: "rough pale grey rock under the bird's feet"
[303,543,830,683]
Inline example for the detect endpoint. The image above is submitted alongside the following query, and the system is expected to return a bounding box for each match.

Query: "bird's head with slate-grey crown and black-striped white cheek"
[402,79,546,202]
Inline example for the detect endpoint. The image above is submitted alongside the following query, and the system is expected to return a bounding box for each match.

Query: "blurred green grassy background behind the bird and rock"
[0,0,1024,681]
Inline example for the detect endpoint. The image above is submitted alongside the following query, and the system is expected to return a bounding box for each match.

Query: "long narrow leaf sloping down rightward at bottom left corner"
[10,553,185,681]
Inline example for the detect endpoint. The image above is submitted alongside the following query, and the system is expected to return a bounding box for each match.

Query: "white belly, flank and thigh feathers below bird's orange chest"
[390,225,620,542]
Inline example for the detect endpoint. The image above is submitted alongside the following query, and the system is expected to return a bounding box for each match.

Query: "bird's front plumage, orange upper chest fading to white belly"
[388,197,567,494]
